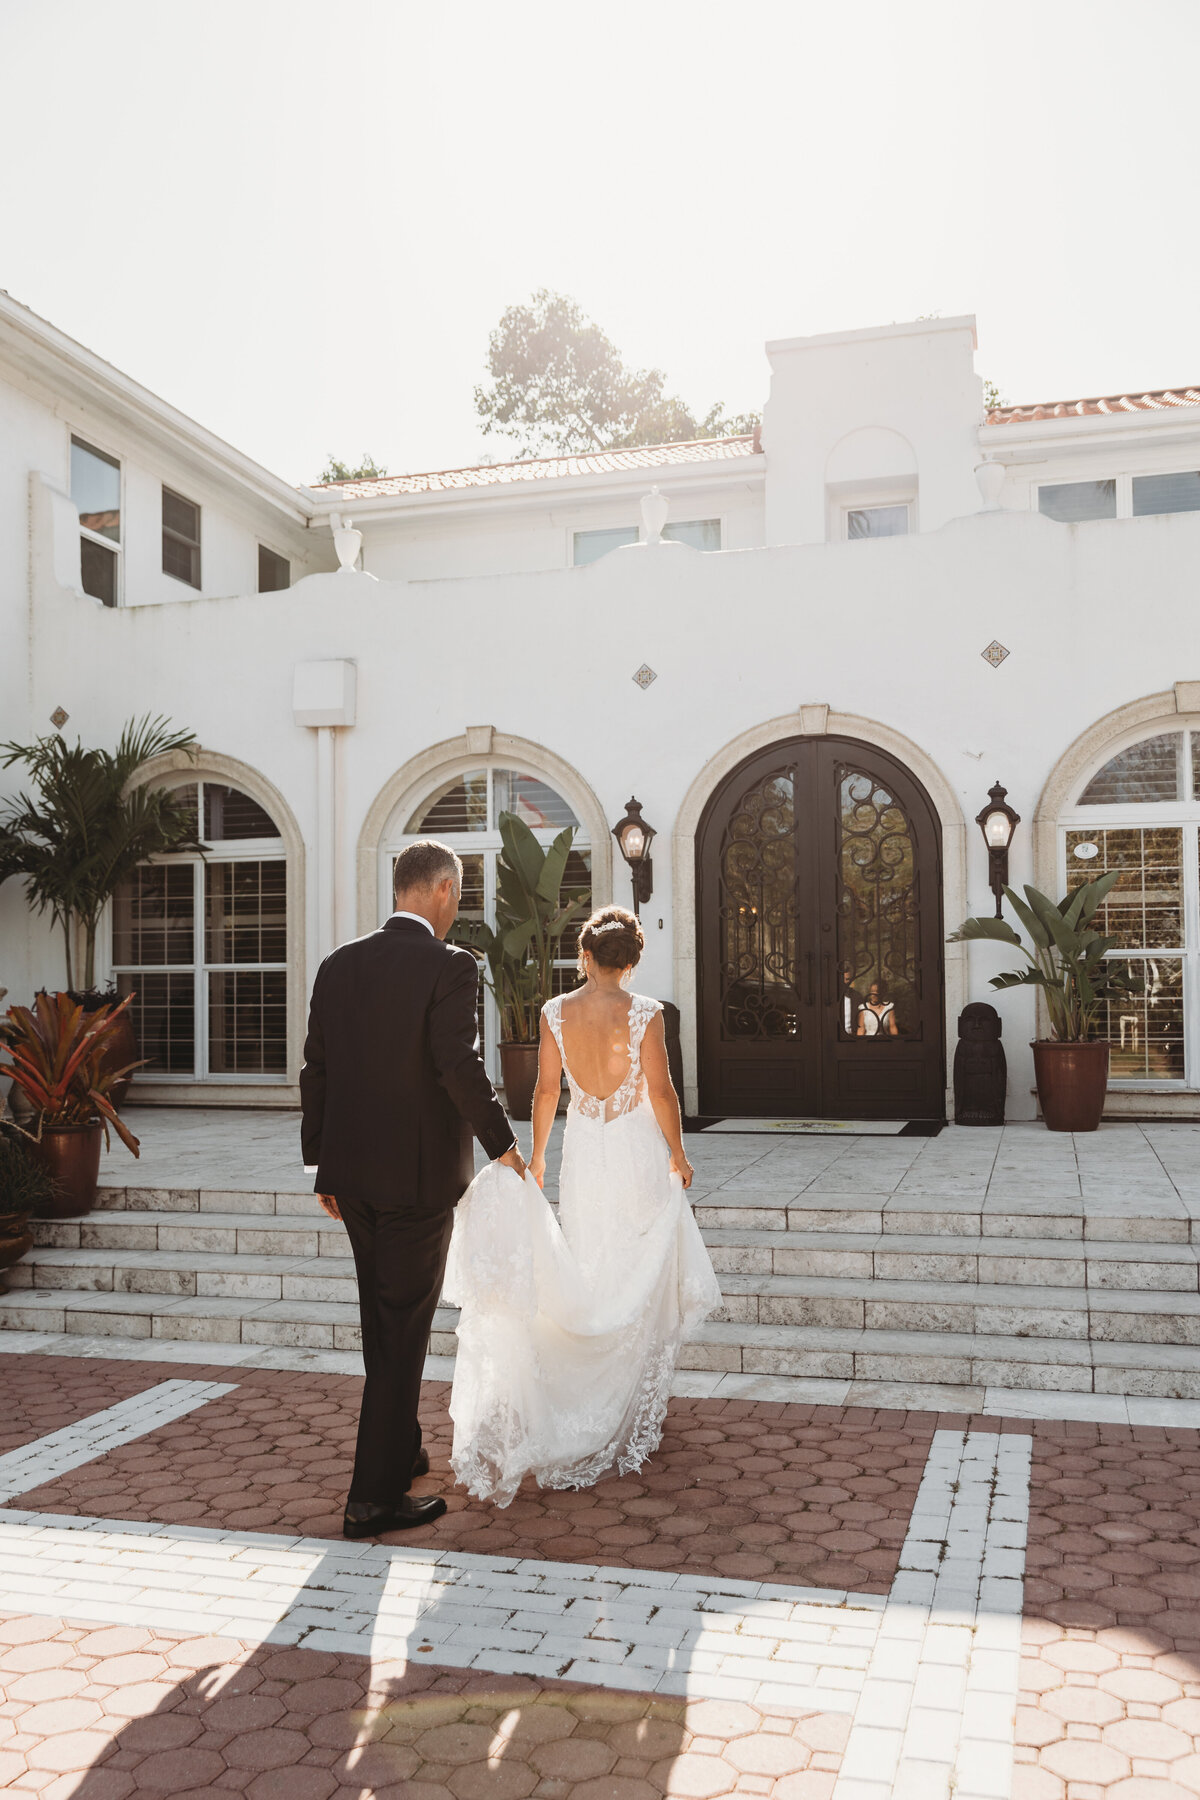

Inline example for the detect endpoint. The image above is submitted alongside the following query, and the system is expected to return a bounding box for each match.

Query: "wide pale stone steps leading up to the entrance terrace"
[0,1186,1200,1399]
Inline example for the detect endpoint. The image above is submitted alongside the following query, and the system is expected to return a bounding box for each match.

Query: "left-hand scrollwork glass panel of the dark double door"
[720,770,799,1039]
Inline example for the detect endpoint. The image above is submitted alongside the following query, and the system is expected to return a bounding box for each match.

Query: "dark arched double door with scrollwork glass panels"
[696,738,945,1120]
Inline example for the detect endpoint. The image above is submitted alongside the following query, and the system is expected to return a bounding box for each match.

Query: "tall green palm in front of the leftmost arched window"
[0,715,205,990]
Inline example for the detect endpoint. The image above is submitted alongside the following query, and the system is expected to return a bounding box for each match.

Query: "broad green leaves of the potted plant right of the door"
[950,869,1132,1044]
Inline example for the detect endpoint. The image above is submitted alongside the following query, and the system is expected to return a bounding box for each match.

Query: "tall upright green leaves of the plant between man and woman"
[452,812,588,1044]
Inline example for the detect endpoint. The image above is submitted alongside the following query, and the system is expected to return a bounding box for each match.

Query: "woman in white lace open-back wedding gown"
[443,907,721,1507]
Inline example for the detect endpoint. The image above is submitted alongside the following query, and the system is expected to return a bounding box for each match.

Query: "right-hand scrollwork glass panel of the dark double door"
[838,769,921,1040]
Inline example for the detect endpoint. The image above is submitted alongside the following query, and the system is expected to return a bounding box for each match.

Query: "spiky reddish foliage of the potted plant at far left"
[0,994,142,1156]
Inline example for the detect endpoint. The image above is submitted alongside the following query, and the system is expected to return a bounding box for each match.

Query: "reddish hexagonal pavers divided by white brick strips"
[0,1354,1200,1800]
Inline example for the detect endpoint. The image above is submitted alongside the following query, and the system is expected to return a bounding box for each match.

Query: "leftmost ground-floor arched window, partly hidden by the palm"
[112,779,288,1084]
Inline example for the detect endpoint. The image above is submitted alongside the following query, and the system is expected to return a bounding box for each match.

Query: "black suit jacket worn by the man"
[300,916,516,1213]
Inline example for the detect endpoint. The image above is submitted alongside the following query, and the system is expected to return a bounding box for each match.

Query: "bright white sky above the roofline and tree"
[0,0,1200,482]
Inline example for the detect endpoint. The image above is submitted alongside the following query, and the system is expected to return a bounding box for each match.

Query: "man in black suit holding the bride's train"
[300,839,525,1537]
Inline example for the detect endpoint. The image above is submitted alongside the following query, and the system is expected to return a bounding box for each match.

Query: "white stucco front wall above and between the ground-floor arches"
[14,486,1200,1116]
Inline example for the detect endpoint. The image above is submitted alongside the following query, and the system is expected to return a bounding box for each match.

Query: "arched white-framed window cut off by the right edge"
[1060,722,1200,1087]
